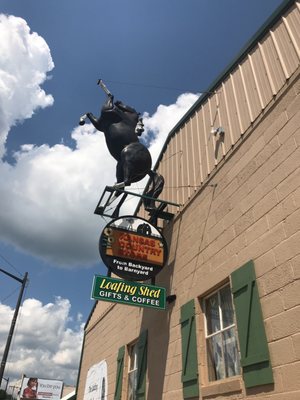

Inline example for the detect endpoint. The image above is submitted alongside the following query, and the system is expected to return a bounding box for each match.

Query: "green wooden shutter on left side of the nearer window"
[180,300,199,399]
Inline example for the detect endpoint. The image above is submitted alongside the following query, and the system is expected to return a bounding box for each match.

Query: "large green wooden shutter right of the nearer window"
[231,261,274,388]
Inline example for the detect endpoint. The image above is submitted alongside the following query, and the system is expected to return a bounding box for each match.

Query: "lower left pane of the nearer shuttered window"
[207,334,225,381]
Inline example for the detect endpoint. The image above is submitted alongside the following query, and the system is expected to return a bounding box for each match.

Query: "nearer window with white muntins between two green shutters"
[204,285,240,381]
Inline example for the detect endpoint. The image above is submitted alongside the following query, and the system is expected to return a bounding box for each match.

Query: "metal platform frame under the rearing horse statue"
[94,186,181,225]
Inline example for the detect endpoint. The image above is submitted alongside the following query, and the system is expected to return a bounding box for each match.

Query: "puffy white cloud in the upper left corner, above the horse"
[0,14,54,158]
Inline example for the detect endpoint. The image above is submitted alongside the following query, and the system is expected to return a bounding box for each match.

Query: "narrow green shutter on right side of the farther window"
[136,331,148,400]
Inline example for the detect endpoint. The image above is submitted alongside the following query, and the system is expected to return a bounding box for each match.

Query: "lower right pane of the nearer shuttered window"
[223,328,240,377]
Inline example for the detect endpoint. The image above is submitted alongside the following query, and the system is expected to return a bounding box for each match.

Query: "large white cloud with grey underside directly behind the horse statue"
[0,94,197,266]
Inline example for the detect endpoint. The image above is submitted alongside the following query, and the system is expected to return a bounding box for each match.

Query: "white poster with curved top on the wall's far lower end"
[83,360,107,400]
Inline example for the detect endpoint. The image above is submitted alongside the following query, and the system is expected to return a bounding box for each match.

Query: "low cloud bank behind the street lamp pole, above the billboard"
[0,297,83,385]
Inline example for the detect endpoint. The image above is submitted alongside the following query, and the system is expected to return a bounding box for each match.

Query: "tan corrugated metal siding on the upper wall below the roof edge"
[140,1,300,219]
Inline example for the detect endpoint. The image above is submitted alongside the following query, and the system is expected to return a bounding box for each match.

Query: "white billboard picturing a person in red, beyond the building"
[20,377,63,400]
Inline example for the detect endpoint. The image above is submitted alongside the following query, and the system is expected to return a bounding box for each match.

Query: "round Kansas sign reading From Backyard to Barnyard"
[99,216,168,281]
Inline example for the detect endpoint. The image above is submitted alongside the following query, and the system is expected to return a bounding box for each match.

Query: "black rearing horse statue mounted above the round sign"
[79,80,164,211]
